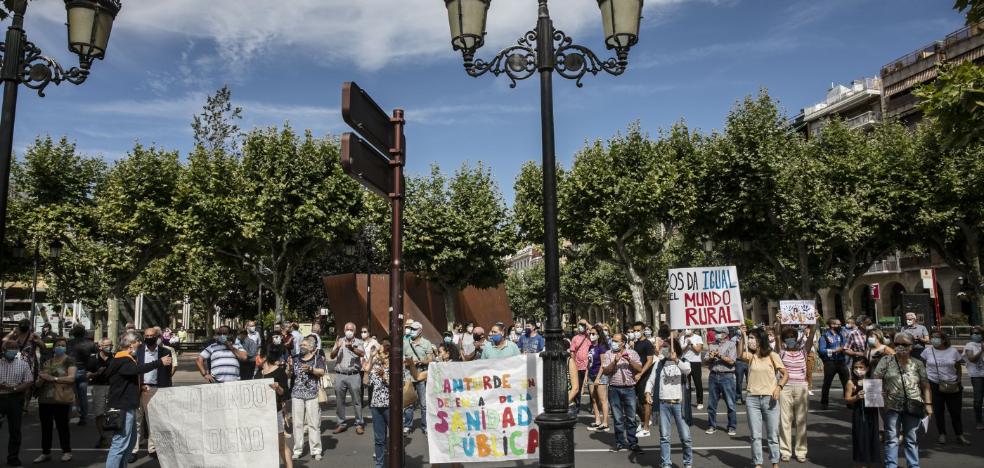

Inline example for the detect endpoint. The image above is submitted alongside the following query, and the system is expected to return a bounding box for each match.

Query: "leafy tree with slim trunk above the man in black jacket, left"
[95,144,181,340]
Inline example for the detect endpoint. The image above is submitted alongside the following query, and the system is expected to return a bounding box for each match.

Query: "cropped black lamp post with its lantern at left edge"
[0,0,122,264]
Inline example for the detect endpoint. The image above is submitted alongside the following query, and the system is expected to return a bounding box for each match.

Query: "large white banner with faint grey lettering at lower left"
[147,379,280,468]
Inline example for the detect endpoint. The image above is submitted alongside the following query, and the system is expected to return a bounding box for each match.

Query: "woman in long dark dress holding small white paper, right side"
[844,357,881,467]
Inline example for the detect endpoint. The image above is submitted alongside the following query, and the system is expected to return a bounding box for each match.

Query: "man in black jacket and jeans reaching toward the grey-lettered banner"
[106,330,173,468]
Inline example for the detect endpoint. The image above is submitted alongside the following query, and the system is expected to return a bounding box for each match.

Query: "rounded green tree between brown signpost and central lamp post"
[404,163,513,325]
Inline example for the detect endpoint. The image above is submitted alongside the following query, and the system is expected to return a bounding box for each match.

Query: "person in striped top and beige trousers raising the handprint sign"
[776,324,816,463]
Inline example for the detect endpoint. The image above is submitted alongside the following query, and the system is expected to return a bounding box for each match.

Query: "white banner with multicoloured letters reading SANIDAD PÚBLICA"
[427,354,542,464]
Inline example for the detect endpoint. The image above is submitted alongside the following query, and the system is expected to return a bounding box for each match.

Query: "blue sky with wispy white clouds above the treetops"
[15,0,963,203]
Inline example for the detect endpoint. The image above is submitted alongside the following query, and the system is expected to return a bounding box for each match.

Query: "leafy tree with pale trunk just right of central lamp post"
[560,124,701,320]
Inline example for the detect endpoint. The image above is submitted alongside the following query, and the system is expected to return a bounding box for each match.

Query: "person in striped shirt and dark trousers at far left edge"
[0,341,34,466]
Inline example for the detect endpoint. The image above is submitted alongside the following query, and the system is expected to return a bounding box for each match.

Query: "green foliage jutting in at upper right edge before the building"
[914,61,984,148]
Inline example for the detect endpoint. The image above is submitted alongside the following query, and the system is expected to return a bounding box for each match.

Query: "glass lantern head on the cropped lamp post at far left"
[65,0,122,68]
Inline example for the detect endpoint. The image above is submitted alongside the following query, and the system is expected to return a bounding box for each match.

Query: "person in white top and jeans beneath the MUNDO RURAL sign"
[646,334,694,468]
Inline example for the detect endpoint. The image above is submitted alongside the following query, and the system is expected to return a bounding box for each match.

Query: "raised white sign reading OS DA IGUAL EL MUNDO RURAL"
[668,266,745,330]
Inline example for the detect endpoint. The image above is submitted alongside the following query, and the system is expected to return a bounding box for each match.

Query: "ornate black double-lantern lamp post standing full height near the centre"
[444,0,643,467]
